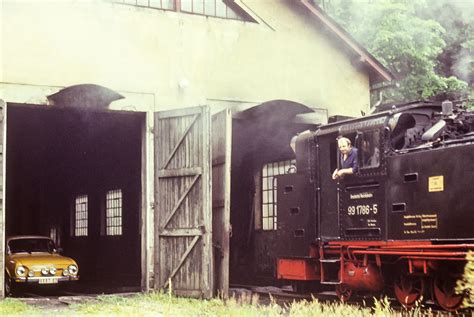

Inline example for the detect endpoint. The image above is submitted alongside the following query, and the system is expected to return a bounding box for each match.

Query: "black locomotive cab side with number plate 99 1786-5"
[313,115,387,241]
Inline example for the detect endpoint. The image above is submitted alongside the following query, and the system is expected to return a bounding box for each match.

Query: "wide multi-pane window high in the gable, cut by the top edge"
[114,0,245,20]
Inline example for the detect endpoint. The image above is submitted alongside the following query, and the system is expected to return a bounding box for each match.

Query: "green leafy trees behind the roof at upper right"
[316,0,474,101]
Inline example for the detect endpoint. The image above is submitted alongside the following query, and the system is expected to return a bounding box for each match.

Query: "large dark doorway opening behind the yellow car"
[5,104,145,293]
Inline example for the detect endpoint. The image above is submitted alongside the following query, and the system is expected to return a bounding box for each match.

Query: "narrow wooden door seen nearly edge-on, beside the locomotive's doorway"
[212,109,232,297]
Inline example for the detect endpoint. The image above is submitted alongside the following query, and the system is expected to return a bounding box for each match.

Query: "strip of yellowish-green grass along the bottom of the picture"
[0,292,440,317]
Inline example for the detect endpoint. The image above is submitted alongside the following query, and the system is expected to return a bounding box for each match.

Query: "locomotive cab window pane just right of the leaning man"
[357,130,380,169]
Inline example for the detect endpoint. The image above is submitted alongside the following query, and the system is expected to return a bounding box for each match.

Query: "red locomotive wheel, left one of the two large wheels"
[394,275,425,308]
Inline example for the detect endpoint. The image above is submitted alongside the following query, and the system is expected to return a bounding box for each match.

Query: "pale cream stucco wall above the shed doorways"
[0,0,369,115]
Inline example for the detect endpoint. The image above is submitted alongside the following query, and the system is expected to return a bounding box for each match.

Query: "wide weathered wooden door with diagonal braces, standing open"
[154,107,213,298]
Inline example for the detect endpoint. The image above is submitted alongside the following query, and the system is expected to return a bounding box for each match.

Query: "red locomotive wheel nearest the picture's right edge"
[431,275,464,311]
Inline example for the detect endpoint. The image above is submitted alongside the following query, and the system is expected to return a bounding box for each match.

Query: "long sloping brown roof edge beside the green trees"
[294,0,395,85]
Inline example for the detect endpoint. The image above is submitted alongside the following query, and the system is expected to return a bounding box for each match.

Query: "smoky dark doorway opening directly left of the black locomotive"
[230,100,315,285]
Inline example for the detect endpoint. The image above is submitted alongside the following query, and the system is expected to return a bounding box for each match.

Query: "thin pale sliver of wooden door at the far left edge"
[0,99,7,298]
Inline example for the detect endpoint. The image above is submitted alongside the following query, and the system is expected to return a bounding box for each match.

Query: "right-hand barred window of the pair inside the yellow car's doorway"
[105,189,122,236]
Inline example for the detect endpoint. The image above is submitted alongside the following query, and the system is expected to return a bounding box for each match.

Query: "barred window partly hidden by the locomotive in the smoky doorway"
[262,160,296,230]
